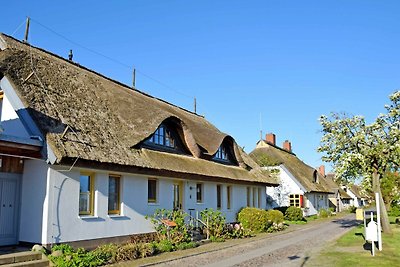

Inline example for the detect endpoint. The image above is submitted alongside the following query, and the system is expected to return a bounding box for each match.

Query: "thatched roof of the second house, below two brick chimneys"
[250,140,333,193]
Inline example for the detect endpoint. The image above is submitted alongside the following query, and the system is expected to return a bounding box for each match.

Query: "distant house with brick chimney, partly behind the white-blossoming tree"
[318,171,352,212]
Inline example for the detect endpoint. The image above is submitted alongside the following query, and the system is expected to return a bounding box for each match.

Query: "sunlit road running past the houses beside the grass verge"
[148,214,357,267]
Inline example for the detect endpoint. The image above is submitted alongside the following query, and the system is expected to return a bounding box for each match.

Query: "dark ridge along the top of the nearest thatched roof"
[0,32,205,118]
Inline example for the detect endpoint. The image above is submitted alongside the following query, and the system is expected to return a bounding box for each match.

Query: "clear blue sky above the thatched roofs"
[0,0,400,173]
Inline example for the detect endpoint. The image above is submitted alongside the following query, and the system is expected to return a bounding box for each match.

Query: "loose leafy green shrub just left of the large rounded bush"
[200,209,226,241]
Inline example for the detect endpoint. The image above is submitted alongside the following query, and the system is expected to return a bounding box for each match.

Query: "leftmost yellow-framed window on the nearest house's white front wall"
[79,174,94,215]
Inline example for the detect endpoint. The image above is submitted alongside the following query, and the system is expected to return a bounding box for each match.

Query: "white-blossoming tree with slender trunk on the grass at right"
[318,91,400,233]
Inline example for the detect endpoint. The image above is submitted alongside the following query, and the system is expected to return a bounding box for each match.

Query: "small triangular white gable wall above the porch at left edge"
[0,94,30,138]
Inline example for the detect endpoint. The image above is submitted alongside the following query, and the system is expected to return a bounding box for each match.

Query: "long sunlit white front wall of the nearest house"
[42,167,265,244]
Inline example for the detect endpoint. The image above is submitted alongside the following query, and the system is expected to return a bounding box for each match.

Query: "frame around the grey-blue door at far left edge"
[0,172,22,246]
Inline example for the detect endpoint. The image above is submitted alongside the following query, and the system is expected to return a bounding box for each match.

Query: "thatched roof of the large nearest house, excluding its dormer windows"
[0,34,275,184]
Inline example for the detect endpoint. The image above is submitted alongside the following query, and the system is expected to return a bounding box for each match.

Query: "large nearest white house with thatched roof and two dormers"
[0,34,277,247]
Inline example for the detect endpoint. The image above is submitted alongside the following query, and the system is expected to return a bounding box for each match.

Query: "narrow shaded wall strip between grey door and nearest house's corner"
[19,160,48,243]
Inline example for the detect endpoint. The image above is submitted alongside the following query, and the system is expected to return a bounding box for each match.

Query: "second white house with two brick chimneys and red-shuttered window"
[250,134,333,216]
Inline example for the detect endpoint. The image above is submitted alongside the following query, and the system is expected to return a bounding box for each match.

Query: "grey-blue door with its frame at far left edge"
[0,173,19,246]
